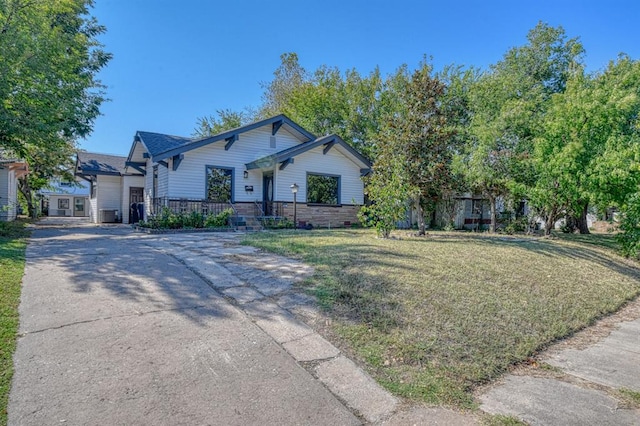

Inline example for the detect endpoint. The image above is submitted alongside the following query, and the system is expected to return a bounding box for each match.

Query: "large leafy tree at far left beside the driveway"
[0,0,111,214]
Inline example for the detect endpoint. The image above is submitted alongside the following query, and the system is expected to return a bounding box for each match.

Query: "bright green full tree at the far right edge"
[531,56,640,233]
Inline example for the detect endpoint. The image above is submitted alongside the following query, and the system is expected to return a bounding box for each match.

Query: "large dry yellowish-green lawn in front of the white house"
[245,230,640,407]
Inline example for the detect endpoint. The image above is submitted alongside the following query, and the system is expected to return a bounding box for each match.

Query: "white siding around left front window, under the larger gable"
[168,125,300,202]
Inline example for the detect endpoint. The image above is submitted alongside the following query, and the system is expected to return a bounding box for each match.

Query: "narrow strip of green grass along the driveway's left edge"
[0,222,28,425]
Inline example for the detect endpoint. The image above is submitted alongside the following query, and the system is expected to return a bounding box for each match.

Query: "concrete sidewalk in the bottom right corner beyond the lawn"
[479,300,640,426]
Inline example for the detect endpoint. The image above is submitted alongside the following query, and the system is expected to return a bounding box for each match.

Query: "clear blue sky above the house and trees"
[80,0,640,155]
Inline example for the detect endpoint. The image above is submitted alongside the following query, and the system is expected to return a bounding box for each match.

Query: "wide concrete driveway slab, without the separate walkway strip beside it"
[9,226,362,425]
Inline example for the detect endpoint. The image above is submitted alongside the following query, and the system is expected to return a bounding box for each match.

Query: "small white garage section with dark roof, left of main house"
[75,152,144,223]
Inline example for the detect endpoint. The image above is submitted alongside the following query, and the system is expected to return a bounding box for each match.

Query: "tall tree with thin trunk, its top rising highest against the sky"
[462,23,583,232]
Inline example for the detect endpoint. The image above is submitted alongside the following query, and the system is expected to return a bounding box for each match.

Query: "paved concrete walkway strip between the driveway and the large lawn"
[140,230,399,423]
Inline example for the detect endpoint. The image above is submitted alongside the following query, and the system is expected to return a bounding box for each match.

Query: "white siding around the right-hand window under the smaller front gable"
[274,145,364,204]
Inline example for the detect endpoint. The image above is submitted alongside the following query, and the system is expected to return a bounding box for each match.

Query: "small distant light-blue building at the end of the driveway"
[39,178,90,217]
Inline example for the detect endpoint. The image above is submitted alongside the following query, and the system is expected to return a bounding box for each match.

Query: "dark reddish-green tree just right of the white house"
[368,61,457,235]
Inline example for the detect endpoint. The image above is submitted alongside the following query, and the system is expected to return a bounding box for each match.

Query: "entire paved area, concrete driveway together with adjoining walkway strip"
[13,225,471,425]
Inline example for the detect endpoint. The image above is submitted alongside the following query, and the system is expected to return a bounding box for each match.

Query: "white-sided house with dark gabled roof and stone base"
[125,115,371,227]
